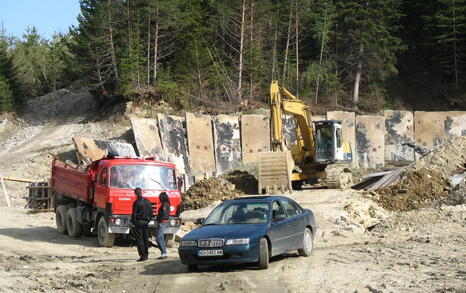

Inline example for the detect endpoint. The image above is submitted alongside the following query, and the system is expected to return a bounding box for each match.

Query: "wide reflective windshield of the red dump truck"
[110,165,176,190]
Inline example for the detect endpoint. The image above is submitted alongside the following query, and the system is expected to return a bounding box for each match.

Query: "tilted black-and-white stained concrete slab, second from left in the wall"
[157,114,191,174]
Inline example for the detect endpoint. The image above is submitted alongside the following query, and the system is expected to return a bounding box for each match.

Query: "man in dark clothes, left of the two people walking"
[131,187,152,261]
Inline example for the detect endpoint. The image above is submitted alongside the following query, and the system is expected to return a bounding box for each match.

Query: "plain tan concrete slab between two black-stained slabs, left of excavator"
[186,113,215,176]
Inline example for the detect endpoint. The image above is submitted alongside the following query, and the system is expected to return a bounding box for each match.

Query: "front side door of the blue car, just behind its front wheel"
[269,200,294,255]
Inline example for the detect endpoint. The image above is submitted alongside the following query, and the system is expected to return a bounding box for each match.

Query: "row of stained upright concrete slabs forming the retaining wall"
[132,110,466,176]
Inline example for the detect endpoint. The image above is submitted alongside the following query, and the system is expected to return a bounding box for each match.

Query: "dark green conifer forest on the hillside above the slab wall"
[0,0,466,112]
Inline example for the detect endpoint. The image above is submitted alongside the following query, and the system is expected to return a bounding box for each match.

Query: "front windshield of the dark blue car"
[204,202,270,225]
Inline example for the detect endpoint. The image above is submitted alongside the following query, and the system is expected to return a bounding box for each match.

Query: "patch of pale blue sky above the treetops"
[0,0,80,39]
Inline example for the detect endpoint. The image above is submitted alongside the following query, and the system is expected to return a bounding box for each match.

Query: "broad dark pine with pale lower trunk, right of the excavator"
[337,0,403,109]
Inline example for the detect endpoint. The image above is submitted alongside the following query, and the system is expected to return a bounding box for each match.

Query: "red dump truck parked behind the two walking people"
[51,155,181,247]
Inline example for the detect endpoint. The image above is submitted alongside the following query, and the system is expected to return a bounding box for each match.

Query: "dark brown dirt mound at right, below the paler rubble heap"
[374,169,449,212]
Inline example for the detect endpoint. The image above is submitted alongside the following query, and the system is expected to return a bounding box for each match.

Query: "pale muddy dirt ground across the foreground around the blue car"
[0,190,466,292]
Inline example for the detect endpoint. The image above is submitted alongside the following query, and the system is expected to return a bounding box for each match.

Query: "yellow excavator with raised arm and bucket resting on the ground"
[258,81,353,194]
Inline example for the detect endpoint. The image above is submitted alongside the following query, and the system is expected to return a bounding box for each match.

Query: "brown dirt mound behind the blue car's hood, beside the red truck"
[183,178,244,210]
